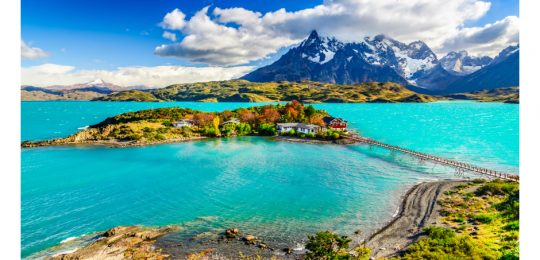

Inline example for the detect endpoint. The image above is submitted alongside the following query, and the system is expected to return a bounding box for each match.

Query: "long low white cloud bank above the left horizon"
[21,64,253,88]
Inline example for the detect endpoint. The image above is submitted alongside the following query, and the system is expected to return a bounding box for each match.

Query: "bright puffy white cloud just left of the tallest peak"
[155,7,295,66]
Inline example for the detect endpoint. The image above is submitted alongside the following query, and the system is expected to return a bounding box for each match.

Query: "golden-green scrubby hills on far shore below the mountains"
[94,80,441,103]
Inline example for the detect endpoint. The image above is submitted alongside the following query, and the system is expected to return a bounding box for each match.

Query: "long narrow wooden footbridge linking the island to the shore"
[343,135,519,182]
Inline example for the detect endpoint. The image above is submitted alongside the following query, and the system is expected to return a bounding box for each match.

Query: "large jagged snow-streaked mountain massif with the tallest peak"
[243,31,438,85]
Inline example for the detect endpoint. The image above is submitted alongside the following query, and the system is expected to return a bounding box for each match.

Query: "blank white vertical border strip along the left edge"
[0,0,21,259]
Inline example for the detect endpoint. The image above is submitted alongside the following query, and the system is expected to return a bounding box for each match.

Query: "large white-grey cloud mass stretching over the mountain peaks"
[154,0,518,65]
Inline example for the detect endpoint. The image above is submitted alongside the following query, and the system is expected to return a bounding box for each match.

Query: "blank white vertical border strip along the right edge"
[519,0,540,259]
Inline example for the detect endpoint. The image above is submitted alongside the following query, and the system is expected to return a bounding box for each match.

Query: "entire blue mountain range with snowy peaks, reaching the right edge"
[241,31,519,94]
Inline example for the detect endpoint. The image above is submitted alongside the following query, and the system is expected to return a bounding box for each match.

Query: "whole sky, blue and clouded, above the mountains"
[21,0,519,87]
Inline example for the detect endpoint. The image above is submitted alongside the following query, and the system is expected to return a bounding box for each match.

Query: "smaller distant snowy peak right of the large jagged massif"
[440,50,493,75]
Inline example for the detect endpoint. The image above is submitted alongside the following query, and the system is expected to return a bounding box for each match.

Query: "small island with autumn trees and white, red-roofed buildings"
[21,101,352,147]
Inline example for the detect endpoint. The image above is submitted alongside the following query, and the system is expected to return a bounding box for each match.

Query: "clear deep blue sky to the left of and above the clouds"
[21,0,322,69]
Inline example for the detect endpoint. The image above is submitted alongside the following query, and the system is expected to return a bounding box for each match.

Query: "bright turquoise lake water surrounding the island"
[21,102,519,257]
